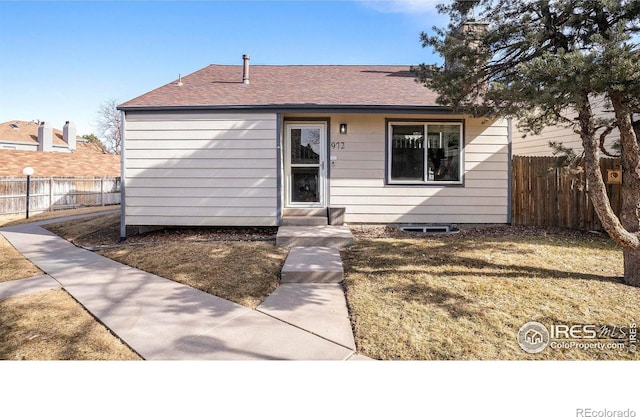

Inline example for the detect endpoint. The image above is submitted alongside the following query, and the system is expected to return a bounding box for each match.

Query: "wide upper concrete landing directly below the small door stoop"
[276,226,354,248]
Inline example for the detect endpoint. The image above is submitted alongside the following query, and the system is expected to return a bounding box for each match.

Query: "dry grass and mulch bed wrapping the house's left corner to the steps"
[46,214,288,308]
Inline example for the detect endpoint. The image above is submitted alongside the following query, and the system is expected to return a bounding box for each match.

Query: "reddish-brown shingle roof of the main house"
[118,65,439,110]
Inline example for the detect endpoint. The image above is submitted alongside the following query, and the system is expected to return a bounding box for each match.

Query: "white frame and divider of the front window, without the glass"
[387,120,465,185]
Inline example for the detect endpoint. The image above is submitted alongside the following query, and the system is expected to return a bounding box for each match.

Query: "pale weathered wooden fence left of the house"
[0,177,120,214]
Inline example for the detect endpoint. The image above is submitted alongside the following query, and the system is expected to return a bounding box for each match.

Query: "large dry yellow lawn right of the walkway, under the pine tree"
[343,229,640,360]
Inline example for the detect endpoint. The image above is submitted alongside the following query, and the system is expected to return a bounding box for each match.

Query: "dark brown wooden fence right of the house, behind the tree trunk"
[512,156,622,230]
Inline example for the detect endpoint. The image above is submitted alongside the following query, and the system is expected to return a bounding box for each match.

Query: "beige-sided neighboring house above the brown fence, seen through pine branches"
[513,101,620,157]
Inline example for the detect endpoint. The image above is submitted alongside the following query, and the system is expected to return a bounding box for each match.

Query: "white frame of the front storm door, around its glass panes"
[284,121,328,208]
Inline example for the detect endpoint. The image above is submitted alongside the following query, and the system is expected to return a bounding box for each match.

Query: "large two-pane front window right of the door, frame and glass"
[387,122,462,184]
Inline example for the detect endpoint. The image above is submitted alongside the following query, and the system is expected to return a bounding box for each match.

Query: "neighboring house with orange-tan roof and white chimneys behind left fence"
[0,120,120,177]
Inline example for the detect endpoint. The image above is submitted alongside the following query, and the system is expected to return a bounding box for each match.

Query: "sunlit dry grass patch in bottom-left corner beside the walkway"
[0,290,140,360]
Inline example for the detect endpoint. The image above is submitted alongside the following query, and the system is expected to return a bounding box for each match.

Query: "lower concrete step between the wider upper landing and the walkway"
[280,246,344,284]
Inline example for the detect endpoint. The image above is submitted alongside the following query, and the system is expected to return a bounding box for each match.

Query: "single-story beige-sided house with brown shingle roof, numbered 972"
[118,56,510,234]
